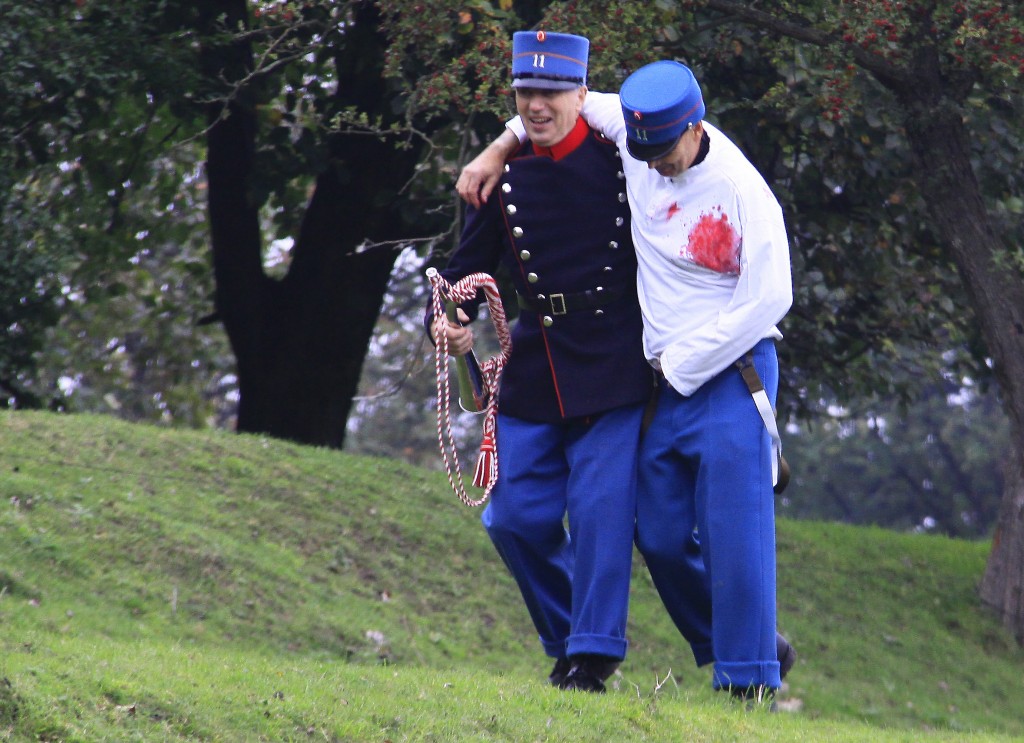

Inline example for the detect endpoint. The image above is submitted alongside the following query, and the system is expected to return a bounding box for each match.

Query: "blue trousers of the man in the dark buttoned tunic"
[481,405,643,660]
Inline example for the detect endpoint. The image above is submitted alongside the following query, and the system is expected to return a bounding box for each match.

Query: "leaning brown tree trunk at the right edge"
[897,56,1024,643]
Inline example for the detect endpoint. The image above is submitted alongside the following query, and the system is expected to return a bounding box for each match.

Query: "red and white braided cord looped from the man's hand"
[428,271,512,507]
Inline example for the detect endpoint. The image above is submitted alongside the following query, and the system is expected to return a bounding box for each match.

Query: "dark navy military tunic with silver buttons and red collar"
[436,119,653,423]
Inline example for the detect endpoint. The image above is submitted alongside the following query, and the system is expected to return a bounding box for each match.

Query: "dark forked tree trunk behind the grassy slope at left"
[197,0,420,448]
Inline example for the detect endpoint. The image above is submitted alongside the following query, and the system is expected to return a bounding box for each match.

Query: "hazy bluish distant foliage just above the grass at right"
[778,386,1010,538]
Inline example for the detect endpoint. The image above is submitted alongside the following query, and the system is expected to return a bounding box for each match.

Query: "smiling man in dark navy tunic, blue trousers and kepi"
[428,31,653,692]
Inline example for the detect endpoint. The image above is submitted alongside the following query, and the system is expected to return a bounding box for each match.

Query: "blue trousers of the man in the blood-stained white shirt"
[637,340,781,689]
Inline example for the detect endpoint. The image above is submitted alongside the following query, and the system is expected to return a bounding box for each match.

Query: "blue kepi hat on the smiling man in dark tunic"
[512,31,590,90]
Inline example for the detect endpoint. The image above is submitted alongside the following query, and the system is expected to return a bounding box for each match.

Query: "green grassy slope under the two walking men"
[0,412,1024,742]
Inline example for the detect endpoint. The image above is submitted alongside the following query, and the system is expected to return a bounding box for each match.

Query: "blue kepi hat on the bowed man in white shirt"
[618,59,705,161]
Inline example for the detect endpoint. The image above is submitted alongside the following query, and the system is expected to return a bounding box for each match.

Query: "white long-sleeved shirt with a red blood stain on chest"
[509,92,793,395]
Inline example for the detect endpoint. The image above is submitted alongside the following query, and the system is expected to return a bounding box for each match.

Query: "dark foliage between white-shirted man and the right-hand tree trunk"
[761,50,988,399]
